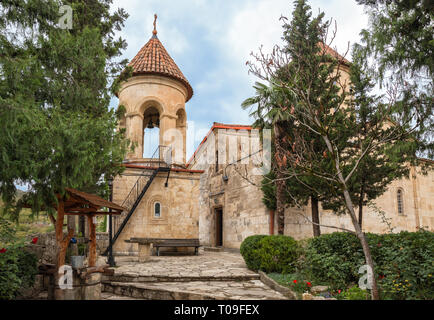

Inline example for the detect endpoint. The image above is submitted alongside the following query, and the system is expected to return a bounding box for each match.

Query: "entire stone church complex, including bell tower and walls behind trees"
[113,21,434,254]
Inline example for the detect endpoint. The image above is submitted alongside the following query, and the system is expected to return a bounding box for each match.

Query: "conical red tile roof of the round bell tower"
[128,32,193,102]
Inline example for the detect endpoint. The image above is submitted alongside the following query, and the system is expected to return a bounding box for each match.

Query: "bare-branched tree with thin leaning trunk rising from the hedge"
[249,0,425,299]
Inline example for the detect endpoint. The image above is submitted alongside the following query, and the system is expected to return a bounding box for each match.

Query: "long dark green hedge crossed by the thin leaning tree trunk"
[305,231,434,300]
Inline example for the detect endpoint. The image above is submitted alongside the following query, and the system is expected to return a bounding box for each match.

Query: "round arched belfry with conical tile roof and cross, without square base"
[118,15,193,165]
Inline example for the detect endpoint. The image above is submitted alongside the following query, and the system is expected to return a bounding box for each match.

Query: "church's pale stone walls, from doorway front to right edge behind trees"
[190,126,434,248]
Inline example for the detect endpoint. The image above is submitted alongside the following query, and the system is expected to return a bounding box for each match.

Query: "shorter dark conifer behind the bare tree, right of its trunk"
[322,46,417,227]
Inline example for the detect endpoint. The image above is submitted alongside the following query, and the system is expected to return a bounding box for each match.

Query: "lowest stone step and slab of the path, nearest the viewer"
[103,280,286,300]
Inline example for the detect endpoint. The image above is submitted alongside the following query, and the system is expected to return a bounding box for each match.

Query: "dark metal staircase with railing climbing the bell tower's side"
[102,146,171,256]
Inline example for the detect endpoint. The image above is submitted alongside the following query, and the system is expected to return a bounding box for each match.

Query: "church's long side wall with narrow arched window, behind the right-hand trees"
[285,164,434,239]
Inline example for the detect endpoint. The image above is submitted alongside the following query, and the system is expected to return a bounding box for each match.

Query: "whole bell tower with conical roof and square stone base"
[113,21,202,254]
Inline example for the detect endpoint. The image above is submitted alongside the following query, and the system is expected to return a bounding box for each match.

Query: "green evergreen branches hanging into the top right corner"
[357,0,434,159]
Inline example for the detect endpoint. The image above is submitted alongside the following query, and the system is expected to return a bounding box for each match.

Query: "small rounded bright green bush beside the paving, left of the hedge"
[240,235,300,273]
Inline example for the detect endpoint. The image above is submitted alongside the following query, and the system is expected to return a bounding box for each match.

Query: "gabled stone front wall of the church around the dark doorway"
[190,130,269,248]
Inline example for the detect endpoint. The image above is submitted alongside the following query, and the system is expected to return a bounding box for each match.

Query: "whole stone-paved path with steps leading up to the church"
[104,250,286,300]
